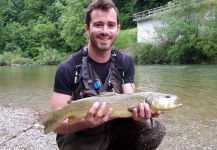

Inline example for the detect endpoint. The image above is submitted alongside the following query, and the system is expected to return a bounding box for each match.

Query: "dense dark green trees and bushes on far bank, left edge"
[0,0,67,65]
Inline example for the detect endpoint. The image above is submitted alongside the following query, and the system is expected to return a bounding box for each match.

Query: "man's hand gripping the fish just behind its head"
[133,103,160,121]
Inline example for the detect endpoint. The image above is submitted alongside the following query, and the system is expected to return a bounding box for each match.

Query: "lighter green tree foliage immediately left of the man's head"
[60,0,89,52]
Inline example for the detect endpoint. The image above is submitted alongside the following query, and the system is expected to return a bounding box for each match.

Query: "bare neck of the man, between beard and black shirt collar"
[88,45,111,63]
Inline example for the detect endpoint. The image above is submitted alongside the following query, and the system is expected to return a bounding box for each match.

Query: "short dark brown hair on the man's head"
[85,0,120,26]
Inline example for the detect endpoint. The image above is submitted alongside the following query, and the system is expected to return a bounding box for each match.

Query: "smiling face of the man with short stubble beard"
[86,8,120,51]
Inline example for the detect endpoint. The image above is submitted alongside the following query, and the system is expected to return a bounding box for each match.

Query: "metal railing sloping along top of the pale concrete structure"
[133,0,203,21]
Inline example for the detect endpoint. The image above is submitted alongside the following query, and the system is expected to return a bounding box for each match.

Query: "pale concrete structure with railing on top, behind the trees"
[133,0,206,43]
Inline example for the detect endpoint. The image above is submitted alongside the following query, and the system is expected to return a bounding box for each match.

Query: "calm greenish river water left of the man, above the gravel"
[0,66,57,109]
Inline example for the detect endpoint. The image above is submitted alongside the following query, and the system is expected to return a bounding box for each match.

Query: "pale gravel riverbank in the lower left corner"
[0,106,58,150]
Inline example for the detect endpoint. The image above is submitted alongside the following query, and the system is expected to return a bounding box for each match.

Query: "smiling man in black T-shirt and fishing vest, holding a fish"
[52,0,165,150]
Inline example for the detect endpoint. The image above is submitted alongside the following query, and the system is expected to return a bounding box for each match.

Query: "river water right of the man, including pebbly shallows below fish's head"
[136,65,217,150]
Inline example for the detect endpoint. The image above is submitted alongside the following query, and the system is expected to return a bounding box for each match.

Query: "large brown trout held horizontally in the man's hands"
[42,92,182,134]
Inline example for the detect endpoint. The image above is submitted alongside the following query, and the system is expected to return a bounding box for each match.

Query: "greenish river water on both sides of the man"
[0,65,217,150]
